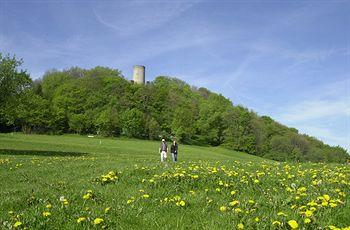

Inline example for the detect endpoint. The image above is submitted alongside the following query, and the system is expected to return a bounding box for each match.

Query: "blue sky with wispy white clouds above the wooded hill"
[0,0,350,150]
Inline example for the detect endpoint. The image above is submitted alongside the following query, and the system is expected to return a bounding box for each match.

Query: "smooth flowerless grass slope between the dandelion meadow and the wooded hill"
[0,133,266,162]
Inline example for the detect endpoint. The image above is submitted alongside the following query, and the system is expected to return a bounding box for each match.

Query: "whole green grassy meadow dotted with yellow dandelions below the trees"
[0,134,350,229]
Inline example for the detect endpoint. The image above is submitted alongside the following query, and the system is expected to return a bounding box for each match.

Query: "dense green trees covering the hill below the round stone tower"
[0,53,349,162]
